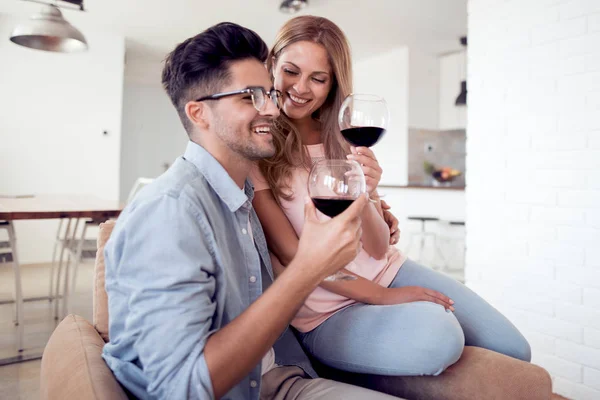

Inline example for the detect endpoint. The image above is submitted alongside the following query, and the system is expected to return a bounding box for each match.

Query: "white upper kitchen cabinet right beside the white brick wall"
[439,51,467,130]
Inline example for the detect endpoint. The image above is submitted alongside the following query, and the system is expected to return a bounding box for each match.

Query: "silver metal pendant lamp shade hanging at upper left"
[10,4,88,53]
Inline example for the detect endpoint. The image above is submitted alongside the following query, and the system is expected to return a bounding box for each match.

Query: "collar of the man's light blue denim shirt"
[183,141,254,212]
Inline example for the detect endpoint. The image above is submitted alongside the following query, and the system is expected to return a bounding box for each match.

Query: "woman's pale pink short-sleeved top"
[250,144,406,332]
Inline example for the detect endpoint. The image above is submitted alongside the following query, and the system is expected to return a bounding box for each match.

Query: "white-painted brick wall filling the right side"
[466,0,600,399]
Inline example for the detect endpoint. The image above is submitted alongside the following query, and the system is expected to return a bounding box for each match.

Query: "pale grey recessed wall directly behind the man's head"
[120,82,188,200]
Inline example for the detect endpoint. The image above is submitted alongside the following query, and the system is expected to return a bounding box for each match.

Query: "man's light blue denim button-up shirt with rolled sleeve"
[103,142,316,400]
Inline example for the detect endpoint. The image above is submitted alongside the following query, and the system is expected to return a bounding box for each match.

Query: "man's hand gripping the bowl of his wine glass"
[294,195,369,281]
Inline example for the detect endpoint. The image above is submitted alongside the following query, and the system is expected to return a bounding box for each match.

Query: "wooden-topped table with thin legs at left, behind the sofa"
[0,195,123,351]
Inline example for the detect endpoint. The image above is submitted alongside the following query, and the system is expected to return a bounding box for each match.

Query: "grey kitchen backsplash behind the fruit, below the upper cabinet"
[408,128,466,186]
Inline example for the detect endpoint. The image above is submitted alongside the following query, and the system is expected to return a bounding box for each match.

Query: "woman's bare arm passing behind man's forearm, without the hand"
[252,189,389,304]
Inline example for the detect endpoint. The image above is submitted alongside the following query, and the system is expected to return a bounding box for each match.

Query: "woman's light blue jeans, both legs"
[300,260,531,376]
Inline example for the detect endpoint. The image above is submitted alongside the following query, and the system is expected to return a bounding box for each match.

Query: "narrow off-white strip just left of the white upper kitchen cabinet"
[408,48,440,130]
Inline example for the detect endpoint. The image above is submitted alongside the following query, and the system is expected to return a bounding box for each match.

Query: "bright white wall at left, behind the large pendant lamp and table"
[0,15,124,263]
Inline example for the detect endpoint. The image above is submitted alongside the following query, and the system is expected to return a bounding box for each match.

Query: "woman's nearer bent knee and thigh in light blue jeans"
[303,302,465,375]
